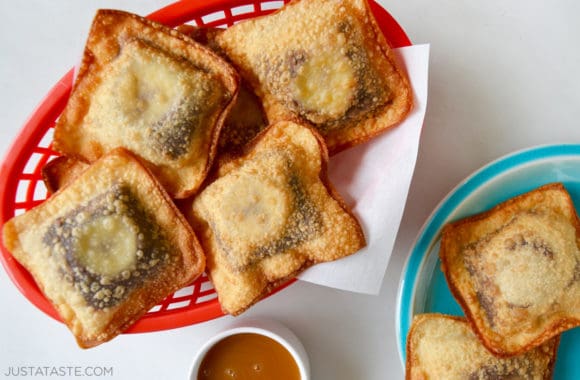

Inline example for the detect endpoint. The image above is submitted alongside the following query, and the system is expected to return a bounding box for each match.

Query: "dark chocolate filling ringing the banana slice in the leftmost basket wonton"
[43,185,170,309]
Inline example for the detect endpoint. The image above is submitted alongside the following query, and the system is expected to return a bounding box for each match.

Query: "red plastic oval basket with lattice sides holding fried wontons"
[0,0,411,332]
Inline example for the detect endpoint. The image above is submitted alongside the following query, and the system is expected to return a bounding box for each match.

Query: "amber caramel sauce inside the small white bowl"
[197,333,300,380]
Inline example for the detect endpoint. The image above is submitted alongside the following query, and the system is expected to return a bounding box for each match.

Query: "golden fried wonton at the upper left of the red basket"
[54,10,239,198]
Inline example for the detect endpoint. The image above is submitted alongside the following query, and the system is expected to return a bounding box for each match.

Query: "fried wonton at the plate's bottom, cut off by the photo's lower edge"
[406,314,559,380]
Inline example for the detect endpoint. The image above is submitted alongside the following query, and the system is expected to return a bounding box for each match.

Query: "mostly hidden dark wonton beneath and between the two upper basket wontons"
[176,24,267,153]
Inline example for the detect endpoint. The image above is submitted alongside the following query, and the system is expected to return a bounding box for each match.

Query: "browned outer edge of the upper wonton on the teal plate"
[439,182,580,357]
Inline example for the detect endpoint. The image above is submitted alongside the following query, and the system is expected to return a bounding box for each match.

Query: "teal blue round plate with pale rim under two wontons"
[397,144,580,380]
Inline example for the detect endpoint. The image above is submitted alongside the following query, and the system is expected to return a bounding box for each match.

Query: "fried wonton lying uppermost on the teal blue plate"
[439,183,580,356]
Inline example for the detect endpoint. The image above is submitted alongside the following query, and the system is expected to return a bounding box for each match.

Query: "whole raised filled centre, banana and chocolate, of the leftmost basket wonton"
[43,186,169,309]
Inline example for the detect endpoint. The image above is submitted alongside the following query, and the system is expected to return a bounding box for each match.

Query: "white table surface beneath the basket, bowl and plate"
[0,0,580,380]
